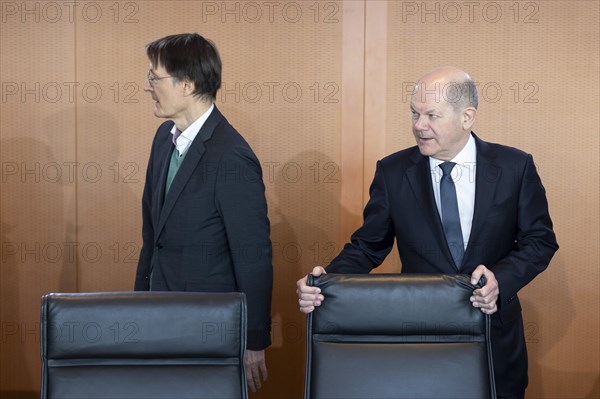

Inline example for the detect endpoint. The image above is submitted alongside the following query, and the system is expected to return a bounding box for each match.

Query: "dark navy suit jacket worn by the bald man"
[327,136,558,395]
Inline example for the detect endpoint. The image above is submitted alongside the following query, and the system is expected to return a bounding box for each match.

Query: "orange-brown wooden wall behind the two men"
[0,0,600,399]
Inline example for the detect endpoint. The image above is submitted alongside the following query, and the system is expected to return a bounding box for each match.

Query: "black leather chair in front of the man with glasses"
[41,292,248,399]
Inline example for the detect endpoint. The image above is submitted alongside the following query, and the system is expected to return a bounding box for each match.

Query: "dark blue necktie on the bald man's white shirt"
[439,162,465,269]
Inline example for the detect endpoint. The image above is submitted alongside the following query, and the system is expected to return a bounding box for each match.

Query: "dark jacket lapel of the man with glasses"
[156,106,223,238]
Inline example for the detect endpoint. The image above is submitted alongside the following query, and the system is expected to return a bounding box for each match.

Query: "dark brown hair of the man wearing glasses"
[146,33,221,100]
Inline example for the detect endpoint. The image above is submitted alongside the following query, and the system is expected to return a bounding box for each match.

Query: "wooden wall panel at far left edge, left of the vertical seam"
[0,9,77,398]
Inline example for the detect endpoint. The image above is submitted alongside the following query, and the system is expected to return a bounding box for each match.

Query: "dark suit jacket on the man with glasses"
[135,107,273,350]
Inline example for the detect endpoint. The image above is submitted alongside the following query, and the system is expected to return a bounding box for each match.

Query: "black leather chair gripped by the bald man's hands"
[304,274,496,399]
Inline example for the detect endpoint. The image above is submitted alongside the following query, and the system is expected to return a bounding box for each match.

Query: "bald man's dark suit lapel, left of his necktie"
[406,150,459,272]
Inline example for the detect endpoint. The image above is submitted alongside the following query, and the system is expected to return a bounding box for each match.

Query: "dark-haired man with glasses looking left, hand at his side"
[135,34,273,392]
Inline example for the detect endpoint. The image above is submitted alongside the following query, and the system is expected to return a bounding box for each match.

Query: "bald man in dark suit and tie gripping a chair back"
[296,67,558,399]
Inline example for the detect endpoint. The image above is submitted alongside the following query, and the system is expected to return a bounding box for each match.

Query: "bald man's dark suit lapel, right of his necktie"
[463,134,502,262]
